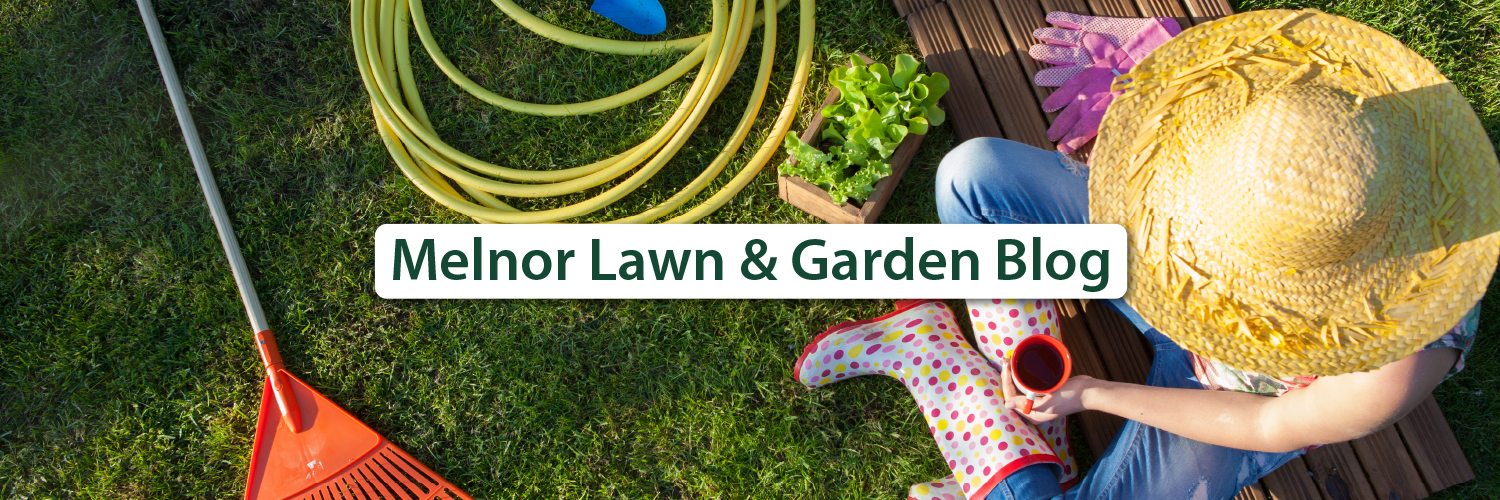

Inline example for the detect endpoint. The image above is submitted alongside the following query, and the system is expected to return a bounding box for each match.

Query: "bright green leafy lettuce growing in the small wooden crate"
[780,54,948,201]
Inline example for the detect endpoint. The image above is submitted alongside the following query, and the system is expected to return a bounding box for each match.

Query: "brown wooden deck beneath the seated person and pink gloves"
[893,0,1475,500]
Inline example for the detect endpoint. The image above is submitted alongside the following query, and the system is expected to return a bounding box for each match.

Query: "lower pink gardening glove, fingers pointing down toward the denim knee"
[1044,33,1134,153]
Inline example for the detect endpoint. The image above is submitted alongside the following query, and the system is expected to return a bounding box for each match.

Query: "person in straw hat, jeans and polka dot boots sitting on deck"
[794,11,1500,498]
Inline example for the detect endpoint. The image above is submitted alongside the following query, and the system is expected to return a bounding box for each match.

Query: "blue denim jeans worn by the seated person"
[938,138,1302,500]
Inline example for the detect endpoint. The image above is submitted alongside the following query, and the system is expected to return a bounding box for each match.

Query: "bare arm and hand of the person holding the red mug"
[1002,348,1458,452]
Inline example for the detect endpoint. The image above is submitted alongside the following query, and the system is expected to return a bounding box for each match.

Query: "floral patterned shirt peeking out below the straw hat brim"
[1193,305,1479,396]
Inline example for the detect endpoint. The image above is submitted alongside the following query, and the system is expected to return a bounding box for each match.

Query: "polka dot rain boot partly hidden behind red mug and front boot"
[966,299,1079,491]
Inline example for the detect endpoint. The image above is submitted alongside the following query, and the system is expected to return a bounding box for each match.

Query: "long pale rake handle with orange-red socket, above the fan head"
[135,0,302,432]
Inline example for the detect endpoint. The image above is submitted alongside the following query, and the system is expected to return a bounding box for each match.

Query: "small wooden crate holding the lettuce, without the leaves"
[776,56,924,224]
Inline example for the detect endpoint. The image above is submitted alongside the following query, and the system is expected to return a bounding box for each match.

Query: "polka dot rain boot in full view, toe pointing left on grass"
[794,300,1062,498]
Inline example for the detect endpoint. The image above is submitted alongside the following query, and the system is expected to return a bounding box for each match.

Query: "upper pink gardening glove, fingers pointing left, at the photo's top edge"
[1031,12,1182,90]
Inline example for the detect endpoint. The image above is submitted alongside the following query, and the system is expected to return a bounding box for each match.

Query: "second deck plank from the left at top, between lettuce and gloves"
[948,0,1053,149]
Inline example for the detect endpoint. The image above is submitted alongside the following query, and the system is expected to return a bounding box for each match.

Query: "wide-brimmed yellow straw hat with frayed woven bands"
[1089,11,1500,377]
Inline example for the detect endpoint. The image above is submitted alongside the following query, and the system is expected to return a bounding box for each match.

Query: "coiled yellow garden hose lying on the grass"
[350,0,815,224]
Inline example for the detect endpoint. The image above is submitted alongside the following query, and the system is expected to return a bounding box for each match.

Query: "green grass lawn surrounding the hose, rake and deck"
[0,0,1500,498]
